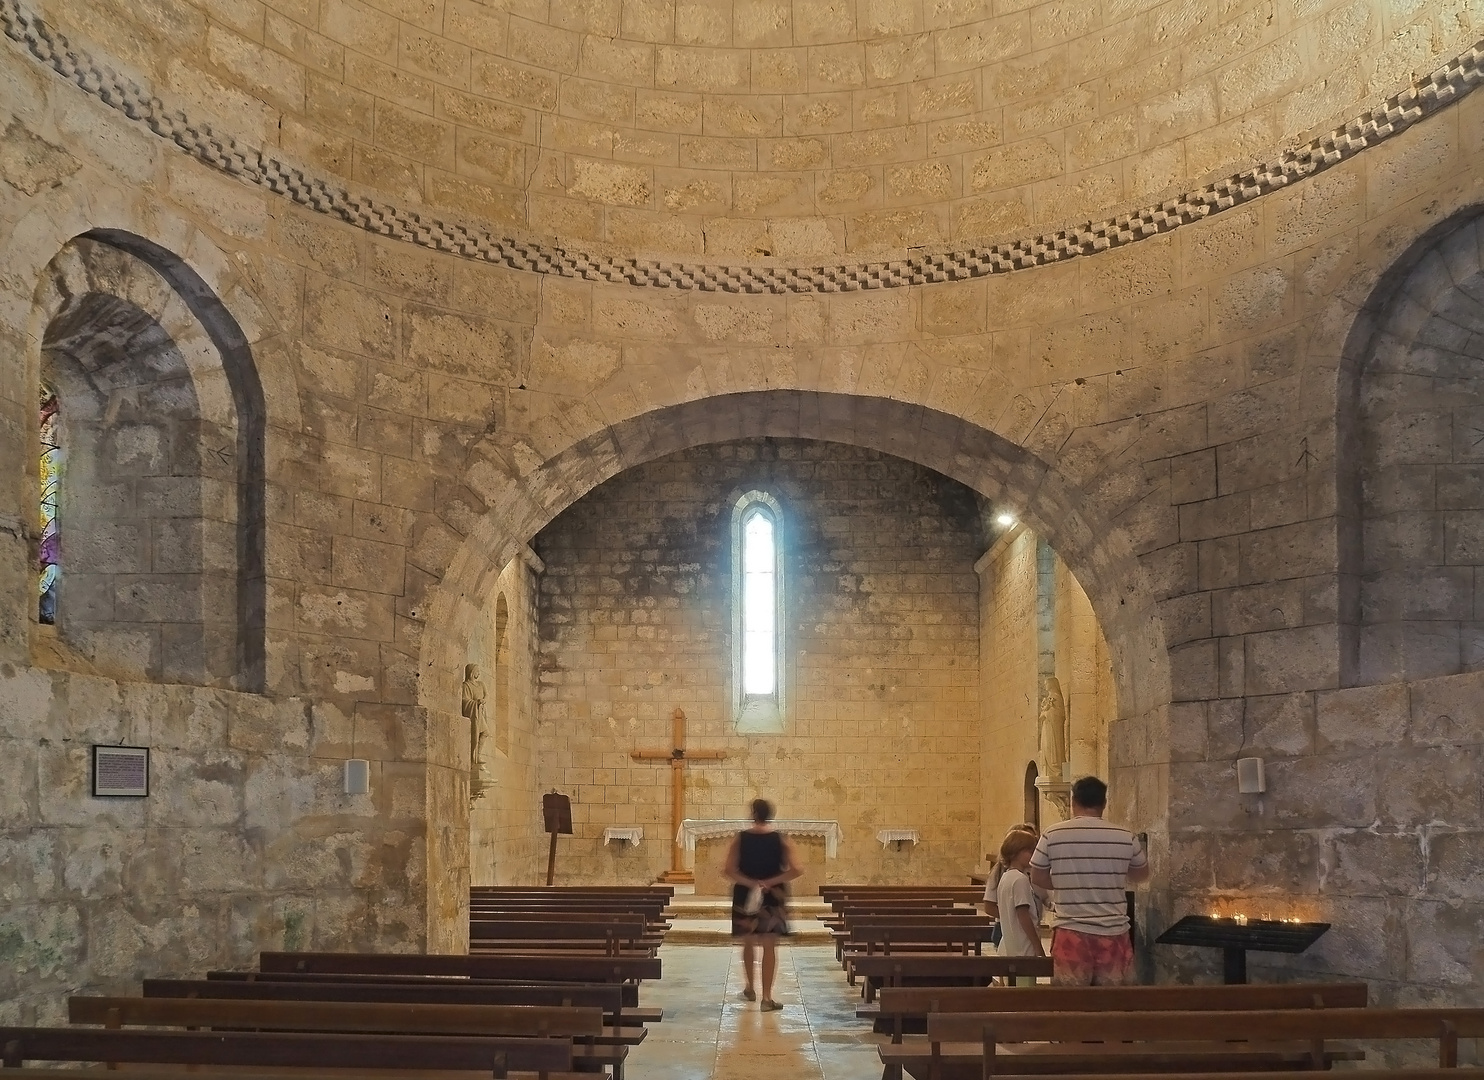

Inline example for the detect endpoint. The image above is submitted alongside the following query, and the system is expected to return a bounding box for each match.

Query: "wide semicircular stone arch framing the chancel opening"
[418,390,1171,750]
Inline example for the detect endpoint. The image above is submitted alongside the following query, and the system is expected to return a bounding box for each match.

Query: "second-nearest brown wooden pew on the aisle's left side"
[67,997,628,1080]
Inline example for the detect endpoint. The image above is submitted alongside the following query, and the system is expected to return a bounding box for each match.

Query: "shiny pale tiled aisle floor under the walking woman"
[625,945,881,1080]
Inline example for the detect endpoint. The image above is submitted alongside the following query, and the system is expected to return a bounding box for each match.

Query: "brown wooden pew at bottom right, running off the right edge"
[880,1007,1484,1080]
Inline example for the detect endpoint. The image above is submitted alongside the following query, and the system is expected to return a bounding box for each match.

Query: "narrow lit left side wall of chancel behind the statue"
[469,555,546,886]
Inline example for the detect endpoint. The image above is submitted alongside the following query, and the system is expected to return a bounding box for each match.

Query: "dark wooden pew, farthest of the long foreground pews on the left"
[258,952,660,982]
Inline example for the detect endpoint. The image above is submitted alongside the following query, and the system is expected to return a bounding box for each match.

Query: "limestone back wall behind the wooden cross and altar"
[534,439,982,883]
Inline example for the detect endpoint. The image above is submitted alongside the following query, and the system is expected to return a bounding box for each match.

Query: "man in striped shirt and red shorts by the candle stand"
[1030,776,1149,987]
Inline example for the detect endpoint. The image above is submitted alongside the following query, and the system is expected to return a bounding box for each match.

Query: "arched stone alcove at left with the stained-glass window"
[37,233,266,690]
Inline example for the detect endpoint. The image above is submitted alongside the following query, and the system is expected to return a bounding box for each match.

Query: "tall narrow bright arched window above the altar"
[732,491,785,731]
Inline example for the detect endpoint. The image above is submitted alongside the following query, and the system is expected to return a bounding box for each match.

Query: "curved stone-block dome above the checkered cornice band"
[23,0,1480,260]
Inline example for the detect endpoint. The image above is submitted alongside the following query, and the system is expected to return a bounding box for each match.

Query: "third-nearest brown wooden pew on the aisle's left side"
[142,975,663,1041]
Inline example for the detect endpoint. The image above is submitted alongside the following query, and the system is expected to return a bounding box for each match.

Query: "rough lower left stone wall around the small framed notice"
[0,662,426,1024]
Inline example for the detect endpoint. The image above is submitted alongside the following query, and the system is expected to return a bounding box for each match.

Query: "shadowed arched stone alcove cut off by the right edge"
[1340,209,1484,684]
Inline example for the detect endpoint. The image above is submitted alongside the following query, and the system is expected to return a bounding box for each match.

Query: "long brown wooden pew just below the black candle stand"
[856,979,1370,1043]
